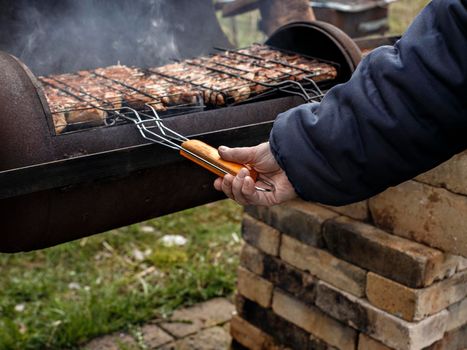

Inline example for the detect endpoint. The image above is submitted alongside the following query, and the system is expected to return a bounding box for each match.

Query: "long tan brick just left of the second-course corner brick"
[280,235,366,296]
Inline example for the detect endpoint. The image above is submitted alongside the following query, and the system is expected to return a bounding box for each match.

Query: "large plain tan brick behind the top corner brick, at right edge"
[370,181,467,257]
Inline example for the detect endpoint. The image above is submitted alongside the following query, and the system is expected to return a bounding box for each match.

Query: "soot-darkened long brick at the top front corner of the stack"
[323,217,459,288]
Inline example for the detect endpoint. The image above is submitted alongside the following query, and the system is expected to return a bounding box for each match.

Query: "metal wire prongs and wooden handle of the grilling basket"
[110,104,275,192]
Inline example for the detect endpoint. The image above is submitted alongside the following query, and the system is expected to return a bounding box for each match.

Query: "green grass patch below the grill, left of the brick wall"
[0,201,241,349]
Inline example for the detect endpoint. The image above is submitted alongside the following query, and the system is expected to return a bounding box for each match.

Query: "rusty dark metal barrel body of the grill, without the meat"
[0,24,359,252]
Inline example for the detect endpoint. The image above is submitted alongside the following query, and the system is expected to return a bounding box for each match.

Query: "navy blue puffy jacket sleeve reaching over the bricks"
[270,0,467,205]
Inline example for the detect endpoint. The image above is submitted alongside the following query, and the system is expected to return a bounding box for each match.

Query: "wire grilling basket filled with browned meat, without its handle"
[39,44,339,134]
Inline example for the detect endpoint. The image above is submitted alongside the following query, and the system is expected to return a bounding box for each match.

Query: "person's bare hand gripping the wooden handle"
[214,142,297,206]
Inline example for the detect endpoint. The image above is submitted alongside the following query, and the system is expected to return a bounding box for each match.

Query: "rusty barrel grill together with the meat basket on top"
[0,22,361,252]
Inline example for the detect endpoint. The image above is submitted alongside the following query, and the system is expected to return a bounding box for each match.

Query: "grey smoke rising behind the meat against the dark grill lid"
[0,0,232,74]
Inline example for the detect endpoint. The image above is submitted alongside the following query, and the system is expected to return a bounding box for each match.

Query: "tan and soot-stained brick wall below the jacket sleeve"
[231,153,467,350]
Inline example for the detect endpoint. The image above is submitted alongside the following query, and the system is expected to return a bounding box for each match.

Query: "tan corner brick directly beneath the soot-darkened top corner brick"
[367,271,467,321]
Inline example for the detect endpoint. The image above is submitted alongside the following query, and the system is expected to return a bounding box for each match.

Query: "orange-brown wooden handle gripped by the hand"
[180,140,258,182]
